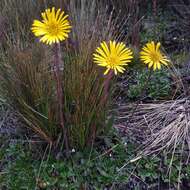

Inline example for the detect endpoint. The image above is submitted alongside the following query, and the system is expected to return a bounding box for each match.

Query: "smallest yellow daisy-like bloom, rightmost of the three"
[140,42,169,70]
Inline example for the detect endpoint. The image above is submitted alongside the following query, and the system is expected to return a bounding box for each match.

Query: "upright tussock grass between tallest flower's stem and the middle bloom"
[60,0,131,147]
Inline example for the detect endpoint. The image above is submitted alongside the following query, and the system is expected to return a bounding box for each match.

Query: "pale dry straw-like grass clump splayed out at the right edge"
[115,98,190,159]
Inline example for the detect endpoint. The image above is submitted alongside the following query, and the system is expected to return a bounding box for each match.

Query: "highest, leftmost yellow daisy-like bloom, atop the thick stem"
[31,7,71,45]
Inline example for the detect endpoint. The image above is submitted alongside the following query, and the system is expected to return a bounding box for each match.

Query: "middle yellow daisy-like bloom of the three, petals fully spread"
[93,41,133,75]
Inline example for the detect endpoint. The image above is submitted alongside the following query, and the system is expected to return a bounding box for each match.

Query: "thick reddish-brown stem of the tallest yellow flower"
[53,43,69,153]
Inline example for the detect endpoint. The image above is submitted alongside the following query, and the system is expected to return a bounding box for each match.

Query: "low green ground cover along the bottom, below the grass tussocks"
[0,137,190,190]
